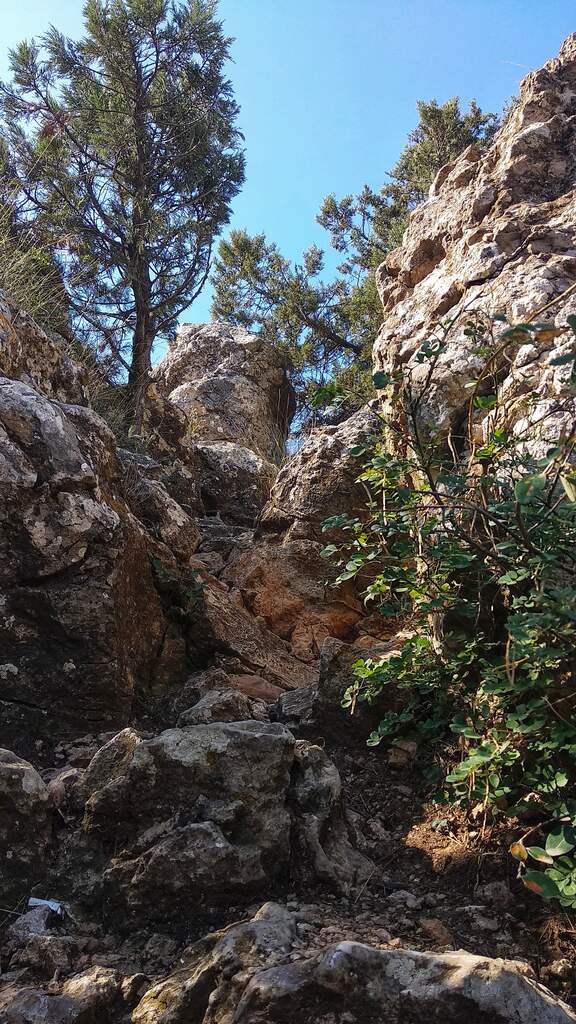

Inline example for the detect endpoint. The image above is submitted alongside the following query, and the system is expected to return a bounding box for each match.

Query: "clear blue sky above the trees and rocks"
[0,0,576,331]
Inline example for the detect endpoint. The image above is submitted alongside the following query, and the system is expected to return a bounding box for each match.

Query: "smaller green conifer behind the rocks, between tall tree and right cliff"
[212,98,498,413]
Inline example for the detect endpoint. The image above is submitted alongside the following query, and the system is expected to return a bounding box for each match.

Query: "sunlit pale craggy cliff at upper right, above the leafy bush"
[374,36,576,446]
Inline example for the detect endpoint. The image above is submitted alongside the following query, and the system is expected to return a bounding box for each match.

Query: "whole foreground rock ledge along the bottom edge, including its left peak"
[131,904,576,1024]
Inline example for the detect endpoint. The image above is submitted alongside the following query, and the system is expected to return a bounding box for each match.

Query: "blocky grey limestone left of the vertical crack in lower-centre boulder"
[67,721,294,922]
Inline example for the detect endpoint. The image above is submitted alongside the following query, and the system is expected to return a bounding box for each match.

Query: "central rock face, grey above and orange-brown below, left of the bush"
[212,409,380,662]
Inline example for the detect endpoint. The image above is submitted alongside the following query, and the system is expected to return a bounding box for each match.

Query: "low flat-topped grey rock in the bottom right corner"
[231,942,576,1024]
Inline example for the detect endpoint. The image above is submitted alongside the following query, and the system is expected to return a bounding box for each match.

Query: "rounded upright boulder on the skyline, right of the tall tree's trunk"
[155,324,294,523]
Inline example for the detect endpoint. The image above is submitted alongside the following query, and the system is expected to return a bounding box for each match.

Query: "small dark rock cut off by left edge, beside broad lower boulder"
[0,750,52,906]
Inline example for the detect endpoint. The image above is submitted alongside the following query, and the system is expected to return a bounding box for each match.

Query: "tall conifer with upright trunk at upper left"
[2,0,244,427]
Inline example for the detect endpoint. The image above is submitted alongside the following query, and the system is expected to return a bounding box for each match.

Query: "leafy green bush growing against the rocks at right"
[324,315,576,905]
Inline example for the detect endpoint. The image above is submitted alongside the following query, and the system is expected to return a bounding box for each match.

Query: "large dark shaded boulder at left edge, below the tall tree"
[0,378,178,755]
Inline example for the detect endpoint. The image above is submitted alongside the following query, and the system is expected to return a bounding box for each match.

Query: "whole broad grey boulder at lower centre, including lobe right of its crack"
[54,720,371,934]
